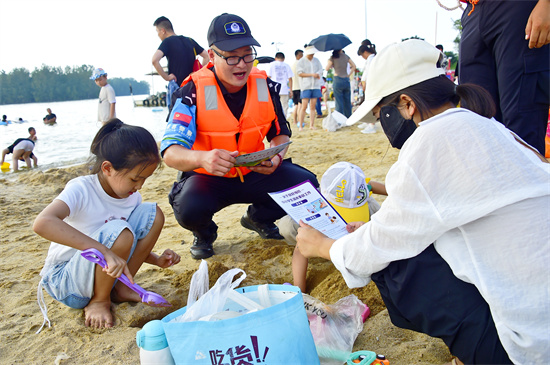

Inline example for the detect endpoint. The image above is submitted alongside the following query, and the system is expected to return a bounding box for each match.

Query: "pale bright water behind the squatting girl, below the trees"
[0,95,168,172]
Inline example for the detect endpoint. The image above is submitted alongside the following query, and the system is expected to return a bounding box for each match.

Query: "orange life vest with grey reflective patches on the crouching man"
[187,64,280,177]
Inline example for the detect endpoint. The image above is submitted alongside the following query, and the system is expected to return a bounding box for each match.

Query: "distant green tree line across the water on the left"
[0,65,149,105]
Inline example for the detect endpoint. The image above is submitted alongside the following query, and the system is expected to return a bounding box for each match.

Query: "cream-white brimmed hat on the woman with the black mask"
[346,39,445,125]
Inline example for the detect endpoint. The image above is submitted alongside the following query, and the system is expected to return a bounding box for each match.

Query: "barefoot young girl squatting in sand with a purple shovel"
[33,119,180,331]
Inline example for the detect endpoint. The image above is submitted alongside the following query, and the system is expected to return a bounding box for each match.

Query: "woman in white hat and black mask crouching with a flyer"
[297,40,550,364]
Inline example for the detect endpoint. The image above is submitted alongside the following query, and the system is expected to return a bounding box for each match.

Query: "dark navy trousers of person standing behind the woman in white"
[459,0,550,156]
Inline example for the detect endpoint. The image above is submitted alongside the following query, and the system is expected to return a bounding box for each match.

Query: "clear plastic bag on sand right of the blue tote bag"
[302,294,370,365]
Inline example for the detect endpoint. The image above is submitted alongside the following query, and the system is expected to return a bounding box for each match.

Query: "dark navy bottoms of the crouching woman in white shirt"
[371,245,512,364]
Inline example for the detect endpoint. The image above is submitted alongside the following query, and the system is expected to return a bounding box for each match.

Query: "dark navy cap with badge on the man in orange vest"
[207,13,261,51]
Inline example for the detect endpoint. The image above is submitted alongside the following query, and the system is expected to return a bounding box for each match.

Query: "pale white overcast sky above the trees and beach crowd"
[0,0,462,91]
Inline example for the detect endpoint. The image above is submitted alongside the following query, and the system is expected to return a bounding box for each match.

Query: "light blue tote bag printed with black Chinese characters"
[162,284,319,365]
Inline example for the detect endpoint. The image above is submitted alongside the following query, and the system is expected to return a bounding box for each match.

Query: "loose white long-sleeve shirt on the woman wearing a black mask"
[330,109,550,364]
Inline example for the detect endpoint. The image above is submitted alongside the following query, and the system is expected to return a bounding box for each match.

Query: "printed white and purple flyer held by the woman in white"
[269,180,348,239]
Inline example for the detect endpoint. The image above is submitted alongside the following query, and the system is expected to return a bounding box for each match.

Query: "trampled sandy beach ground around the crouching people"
[0,112,451,365]
